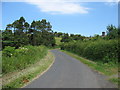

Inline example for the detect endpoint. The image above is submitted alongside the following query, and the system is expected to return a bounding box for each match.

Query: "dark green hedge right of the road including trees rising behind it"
[61,25,120,63]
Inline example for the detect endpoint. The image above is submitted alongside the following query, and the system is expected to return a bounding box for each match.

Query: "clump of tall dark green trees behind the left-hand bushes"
[2,17,55,49]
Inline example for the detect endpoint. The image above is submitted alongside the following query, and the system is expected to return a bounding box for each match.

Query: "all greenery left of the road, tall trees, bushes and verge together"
[0,17,55,88]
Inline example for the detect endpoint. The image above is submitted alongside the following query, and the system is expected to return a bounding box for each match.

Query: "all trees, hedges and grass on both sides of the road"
[0,17,120,88]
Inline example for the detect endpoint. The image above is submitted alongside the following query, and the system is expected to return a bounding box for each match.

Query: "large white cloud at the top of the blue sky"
[25,0,89,14]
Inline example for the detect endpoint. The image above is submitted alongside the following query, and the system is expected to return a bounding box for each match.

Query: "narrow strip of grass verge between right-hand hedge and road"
[61,50,120,85]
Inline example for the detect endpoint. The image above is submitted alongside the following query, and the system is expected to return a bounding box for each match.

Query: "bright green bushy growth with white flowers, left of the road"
[2,46,47,74]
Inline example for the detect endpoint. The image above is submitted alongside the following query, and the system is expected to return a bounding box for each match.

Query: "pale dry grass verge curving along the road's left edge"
[3,52,54,89]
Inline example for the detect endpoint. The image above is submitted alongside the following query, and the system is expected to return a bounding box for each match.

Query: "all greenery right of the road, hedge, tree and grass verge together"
[61,25,120,83]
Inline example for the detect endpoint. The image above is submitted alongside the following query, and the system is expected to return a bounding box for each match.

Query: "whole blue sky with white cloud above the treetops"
[0,0,118,36]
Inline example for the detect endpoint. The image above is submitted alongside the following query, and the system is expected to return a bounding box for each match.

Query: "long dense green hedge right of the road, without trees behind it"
[61,39,118,63]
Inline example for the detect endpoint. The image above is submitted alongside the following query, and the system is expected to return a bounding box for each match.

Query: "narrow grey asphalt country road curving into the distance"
[25,50,115,88]
